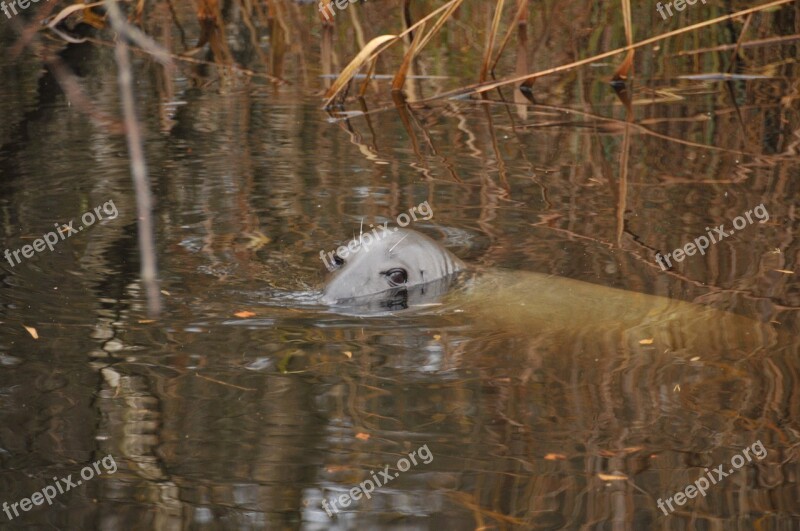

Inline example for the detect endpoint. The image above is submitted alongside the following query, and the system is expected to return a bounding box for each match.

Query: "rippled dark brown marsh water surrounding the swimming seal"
[0,3,800,530]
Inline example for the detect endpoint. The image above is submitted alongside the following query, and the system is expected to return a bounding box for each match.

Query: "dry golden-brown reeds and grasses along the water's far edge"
[11,0,800,106]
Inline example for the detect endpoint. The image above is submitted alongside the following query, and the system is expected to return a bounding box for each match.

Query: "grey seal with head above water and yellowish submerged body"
[321,229,772,352]
